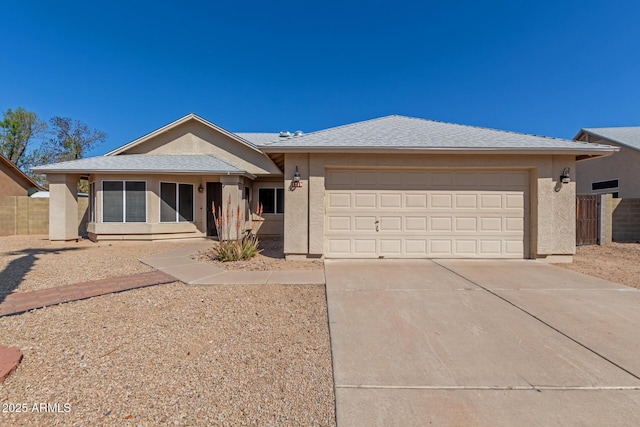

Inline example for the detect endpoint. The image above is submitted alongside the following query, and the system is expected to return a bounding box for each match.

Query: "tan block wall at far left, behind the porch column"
[0,196,89,236]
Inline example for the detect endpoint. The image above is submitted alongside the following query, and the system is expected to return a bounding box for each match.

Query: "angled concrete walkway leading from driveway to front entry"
[141,240,325,285]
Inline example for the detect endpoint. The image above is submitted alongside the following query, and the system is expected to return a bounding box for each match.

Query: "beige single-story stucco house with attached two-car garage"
[34,114,616,261]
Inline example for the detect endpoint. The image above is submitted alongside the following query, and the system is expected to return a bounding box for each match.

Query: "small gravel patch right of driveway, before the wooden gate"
[556,242,640,288]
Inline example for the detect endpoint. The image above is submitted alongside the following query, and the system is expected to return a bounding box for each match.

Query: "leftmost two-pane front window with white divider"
[102,181,147,222]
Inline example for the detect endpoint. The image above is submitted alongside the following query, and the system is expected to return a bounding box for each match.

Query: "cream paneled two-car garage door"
[325,170,528,258]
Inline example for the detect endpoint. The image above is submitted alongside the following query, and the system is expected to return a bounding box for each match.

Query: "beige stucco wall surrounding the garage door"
[284,154,575,258]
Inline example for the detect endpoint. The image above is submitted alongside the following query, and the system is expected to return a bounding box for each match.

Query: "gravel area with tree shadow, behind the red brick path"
[0,236,189,297]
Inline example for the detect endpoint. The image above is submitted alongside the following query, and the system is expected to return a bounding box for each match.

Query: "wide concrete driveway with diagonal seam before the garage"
[325,260,640,426]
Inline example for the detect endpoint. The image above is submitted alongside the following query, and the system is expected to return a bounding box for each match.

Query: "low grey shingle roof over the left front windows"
[32,154,246,175]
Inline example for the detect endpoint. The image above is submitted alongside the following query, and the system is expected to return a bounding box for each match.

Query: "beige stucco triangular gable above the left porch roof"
[121,120,281,175]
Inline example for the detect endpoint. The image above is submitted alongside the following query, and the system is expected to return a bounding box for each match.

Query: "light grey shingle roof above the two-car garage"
[261,115,616,155]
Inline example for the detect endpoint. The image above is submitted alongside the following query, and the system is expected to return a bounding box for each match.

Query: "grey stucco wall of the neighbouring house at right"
[575,147,640,198]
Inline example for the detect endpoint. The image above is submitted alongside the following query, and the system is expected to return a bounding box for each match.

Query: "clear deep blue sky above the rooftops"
[0,0,640,155]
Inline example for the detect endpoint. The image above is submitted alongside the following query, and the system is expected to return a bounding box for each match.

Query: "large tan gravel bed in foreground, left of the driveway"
[0,282,335,426]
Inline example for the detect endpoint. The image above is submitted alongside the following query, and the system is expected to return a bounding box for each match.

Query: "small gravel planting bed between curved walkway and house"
[193,238,324,271]
